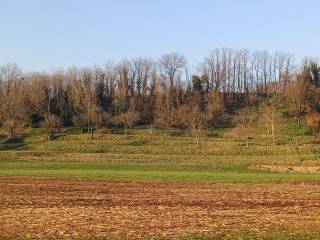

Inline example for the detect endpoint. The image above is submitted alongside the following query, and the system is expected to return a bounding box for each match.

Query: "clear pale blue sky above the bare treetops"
[0,0,320,71]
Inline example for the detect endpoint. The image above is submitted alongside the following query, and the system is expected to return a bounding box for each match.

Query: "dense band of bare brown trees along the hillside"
[0,48,320,142]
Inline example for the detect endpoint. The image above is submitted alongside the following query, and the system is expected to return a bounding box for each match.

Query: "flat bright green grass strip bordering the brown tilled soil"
[0,160,320,183]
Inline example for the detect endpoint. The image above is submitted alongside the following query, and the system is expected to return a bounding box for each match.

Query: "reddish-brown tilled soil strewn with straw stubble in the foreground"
[0,177,320,239]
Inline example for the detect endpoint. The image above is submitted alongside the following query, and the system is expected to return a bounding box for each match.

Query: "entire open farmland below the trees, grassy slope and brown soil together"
[0,127,320,239]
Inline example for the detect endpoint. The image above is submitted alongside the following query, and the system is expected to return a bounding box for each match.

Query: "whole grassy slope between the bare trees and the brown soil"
[0,124,320,183]
